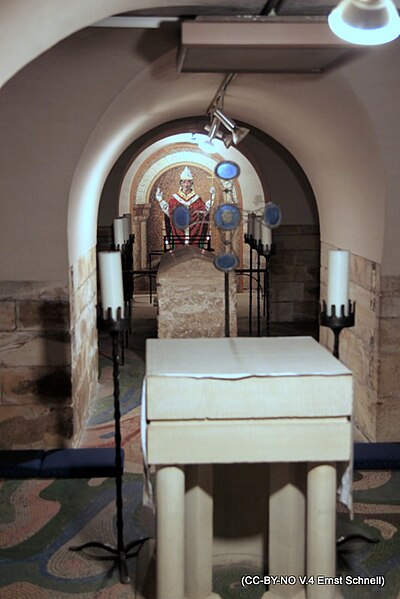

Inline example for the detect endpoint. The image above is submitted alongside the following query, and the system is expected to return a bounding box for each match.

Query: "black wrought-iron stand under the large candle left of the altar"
[70,305,149,584]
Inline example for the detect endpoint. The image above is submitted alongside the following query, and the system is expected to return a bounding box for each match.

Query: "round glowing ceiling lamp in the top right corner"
[328,0,400,46]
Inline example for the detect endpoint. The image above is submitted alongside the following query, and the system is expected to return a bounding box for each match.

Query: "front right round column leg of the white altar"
[307,463,337,599]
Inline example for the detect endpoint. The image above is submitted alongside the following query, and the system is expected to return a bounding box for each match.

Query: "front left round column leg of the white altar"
[156,466,185,599]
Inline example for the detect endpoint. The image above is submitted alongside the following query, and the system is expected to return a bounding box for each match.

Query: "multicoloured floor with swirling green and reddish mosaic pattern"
[0,328,400,599]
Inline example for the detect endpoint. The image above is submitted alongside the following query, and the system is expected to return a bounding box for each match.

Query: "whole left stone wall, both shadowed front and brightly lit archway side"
[0,248,104,449]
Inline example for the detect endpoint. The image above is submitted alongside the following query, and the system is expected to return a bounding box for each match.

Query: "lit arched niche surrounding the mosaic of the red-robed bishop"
[114,132,265,274]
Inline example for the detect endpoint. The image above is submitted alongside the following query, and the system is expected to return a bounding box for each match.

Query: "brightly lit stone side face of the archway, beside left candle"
[70,247,98,444]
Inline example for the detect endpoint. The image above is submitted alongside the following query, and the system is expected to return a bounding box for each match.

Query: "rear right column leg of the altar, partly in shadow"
[264,463,306,599]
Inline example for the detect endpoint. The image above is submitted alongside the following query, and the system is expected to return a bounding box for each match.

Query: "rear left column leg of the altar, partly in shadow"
[185,464,219,599]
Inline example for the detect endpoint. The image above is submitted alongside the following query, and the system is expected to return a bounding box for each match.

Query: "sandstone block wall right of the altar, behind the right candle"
[320,244,400,441]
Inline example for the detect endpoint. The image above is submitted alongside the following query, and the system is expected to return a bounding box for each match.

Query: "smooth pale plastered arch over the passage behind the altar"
[68,52,385,270]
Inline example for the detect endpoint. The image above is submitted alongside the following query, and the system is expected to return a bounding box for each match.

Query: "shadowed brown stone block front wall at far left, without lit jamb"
[0,281,72,449]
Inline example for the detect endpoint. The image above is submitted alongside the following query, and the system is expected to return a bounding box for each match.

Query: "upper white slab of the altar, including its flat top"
[146,337,352,421]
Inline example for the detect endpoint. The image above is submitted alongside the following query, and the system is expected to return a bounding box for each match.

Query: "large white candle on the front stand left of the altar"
[98,251,124,320]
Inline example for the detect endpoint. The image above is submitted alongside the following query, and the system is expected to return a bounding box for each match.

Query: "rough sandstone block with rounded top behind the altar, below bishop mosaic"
[157,246,237,338]
